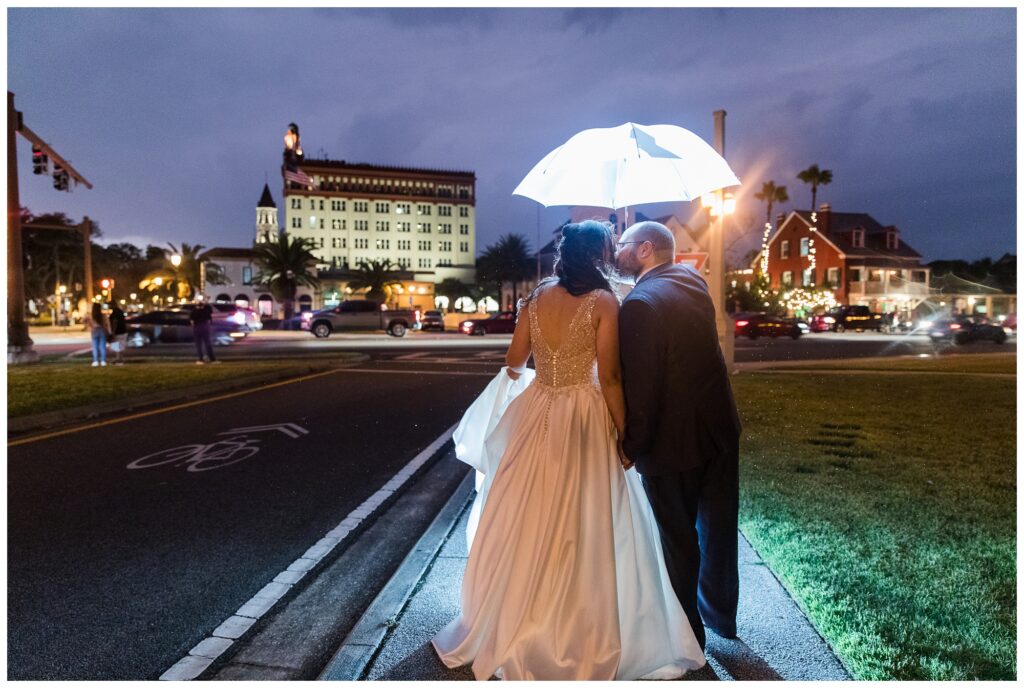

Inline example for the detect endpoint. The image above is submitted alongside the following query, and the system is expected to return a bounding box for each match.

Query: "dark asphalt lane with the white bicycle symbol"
[7,360,497,680]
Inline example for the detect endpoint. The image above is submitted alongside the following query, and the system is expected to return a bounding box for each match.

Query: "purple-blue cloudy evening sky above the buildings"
[8,8,1017,260]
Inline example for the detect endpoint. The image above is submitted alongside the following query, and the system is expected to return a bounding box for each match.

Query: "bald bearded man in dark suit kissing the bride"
[615,222,740,648]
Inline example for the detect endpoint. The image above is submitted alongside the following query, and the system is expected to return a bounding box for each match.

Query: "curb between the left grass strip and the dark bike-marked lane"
[7,354,370,437]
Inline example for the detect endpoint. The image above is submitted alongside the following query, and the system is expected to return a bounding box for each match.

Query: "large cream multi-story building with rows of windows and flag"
[284,159,476,284]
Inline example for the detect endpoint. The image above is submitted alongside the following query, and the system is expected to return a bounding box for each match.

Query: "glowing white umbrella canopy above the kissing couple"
[512,122,739,210]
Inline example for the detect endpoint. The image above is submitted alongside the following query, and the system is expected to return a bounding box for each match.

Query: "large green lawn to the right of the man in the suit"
[733,356,1017,680]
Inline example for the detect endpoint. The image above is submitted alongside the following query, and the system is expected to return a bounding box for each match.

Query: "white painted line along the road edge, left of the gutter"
[160,421,458,681]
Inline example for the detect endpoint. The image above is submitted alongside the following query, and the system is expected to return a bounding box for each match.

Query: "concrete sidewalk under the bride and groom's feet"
[319,474,850,681]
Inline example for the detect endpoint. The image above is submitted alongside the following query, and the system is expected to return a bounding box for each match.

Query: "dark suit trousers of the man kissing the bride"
[641,449,739,648]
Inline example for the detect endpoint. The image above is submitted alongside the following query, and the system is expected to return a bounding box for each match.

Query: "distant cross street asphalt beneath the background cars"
[25,331,1017,362]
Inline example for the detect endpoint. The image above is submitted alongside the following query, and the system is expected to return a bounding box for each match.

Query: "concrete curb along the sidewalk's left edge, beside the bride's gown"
[316,473,475,681]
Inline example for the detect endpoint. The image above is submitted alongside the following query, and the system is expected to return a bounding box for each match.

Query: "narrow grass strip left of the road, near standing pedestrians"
[7,360,329,418]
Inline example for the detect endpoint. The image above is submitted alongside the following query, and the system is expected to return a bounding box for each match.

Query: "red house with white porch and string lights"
[751,204,930,313]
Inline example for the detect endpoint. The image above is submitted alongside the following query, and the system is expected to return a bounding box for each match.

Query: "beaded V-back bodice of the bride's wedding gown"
[527,290,600,388]
